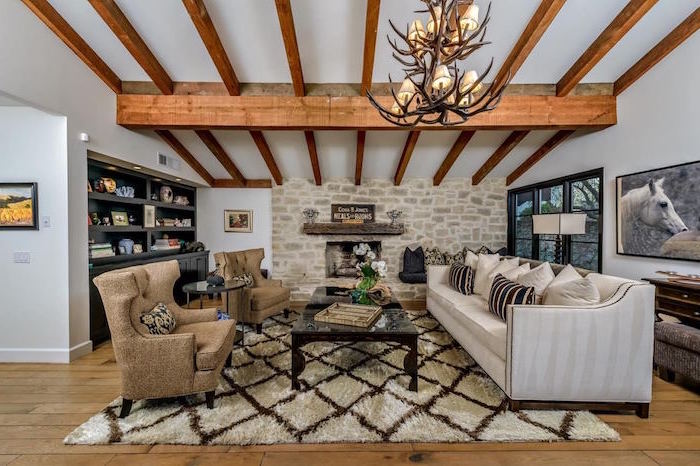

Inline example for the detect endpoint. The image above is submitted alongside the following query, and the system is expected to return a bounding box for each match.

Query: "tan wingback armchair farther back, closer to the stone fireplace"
[214,248,290,333]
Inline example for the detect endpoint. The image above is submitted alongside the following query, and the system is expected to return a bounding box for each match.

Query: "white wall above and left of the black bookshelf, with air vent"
[0,1,208,360]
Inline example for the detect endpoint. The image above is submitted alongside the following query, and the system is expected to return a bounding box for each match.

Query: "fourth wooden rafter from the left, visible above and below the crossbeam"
[275,0,322,186]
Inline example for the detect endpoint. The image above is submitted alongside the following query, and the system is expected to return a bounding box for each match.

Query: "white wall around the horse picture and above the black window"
[511,34,700,278]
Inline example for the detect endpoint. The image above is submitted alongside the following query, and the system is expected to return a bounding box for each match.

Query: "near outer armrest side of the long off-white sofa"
[506,282,654,402]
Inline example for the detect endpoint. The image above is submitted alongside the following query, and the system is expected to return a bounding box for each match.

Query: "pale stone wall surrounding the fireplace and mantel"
[272,178,507,300]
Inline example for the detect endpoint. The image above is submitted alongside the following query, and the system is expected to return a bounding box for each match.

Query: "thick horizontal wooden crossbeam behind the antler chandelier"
[117,94,617,131]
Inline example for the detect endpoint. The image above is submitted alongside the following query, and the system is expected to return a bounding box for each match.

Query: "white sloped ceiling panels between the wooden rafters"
[39,0,700,179]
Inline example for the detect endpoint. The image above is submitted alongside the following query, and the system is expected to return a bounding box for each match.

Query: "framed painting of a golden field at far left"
[0,183,39,230]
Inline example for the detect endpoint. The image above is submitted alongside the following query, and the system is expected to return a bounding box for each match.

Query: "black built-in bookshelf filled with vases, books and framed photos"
[87,159,197,266]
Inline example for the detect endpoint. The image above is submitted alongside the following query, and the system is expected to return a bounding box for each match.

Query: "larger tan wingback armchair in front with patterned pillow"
[93,260,236,418]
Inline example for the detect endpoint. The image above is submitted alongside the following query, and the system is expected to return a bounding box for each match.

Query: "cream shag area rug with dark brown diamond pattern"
[65,312,619,445]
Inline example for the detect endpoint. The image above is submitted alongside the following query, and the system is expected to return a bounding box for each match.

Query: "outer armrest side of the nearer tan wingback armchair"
[117,333,197,399]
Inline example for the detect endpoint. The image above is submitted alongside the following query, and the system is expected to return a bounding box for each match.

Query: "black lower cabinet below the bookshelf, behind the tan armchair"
[90,251,209,346]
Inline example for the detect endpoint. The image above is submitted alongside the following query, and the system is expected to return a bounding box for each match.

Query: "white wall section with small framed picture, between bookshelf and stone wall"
[197,188,274,273]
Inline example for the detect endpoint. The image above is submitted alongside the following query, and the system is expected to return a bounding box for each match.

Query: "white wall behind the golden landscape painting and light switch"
[0,107,76,362]
